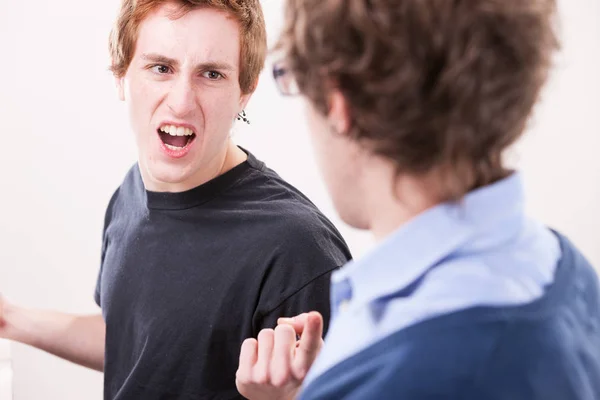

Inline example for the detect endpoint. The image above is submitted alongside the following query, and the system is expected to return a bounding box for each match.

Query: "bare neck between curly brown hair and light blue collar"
[362,159,439,242]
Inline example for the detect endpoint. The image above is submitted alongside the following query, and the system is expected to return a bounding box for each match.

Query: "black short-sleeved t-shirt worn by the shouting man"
[95,153,351,400]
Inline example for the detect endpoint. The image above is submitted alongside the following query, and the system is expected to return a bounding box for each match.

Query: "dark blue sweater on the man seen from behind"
[302,235,600,400]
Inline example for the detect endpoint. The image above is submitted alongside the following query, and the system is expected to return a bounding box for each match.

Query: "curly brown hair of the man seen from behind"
[276,0,559,200]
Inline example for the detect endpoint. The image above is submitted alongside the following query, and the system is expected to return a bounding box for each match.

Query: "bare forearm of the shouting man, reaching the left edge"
[0,298,106,371]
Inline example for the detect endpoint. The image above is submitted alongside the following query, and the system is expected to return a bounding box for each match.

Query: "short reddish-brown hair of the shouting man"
[109,0,267,94]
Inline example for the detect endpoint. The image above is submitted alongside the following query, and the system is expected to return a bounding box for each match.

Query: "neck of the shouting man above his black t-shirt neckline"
[140,140,248,193]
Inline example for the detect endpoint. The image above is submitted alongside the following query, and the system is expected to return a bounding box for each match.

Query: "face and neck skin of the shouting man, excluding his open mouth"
[117,4,250,192]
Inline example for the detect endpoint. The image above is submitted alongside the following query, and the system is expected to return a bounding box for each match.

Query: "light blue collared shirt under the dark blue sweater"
[304,173,561,386]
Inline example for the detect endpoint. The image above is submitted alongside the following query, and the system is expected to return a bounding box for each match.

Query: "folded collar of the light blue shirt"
[332,172,524,308]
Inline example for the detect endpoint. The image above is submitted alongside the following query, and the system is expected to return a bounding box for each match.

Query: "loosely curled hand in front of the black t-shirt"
[235,311,323,400]
